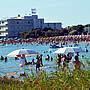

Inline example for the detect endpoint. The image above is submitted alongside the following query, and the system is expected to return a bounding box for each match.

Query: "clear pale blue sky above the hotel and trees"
[0,0,90,27]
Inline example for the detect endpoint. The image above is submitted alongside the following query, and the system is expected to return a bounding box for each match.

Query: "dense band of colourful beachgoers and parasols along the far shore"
[0,35,90,45]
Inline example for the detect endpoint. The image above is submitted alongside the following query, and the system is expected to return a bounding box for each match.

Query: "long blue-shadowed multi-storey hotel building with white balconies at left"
[0,15,62,37]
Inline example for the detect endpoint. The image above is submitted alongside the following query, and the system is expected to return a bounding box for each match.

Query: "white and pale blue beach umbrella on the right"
[54,47,85,54]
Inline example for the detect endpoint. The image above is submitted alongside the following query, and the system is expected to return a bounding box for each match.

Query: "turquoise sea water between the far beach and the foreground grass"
[0,43,90,76]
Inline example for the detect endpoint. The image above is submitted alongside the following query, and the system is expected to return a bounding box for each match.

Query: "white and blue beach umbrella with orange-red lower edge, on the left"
[7,49,39,57]
